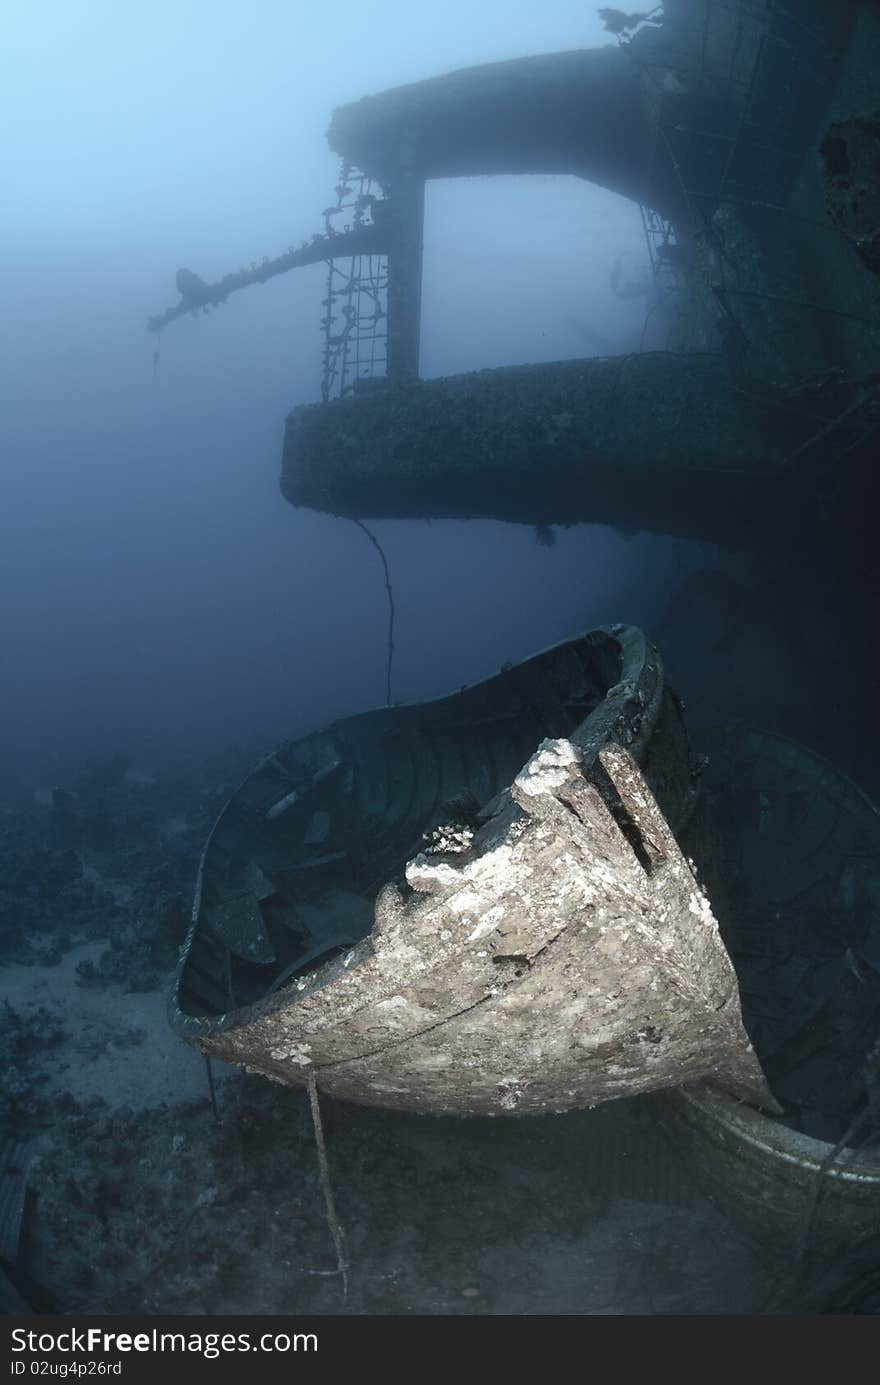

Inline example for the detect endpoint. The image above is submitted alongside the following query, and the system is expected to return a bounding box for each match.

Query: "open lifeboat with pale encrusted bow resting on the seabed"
[172,626,773,1115]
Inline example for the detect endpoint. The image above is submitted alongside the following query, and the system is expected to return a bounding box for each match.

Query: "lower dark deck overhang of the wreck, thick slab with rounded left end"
[281,352,802,546]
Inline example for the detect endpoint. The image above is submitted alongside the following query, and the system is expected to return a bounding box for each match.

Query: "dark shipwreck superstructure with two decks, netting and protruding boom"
[150,0,880,550]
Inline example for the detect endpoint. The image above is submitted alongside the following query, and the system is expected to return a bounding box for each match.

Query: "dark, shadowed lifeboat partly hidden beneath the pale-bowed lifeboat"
[653,727,880,1263]
